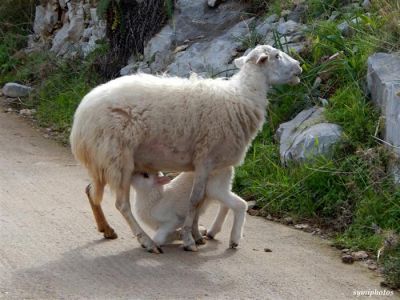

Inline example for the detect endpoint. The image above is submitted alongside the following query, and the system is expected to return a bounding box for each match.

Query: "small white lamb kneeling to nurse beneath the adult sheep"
[132,167,247,248]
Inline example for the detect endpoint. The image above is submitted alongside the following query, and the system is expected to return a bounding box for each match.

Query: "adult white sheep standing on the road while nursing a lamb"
[70,45,301,253]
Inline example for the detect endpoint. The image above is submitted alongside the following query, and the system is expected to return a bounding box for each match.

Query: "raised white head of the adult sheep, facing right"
[234,45,302,85]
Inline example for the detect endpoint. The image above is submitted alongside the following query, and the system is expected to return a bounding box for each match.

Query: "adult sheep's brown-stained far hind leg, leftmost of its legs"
[85,183,118,239]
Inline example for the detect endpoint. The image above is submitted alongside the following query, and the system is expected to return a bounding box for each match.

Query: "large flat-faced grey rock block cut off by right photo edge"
[367,53,400,184]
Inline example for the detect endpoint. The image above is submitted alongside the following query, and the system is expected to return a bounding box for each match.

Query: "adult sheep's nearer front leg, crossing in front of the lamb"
[182,164,212,251]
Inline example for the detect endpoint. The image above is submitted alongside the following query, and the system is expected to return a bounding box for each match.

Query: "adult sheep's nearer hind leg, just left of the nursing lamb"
[115,171,162,253]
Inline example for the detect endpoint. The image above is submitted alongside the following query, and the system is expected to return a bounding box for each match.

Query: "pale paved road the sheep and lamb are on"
[0,107,394,299]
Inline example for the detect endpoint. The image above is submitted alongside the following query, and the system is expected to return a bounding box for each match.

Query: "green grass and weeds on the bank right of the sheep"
[234,0,400,288]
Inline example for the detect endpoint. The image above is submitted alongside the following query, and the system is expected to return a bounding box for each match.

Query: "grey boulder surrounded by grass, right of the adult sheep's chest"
[276,107,342,164]
